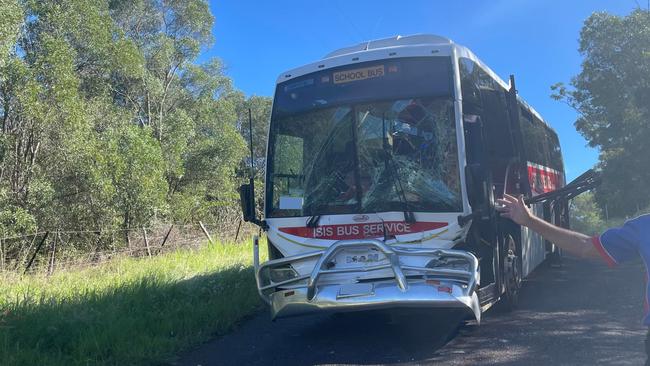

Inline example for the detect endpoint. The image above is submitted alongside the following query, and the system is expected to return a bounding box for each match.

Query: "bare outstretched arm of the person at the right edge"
[497,194,601,259]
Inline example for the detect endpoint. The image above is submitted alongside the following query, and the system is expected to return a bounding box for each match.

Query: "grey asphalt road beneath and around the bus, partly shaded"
[172,258,646,366]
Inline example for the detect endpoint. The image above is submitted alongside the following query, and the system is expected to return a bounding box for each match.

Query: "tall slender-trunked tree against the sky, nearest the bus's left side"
[110,0,245,221]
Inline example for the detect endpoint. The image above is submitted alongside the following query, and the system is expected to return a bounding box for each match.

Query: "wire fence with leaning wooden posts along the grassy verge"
[0,218,258,275]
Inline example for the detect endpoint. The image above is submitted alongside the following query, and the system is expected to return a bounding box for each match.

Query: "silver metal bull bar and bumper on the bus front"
[253,238,481,321]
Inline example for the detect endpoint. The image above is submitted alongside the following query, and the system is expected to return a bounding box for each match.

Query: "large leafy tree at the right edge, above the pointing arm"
[552,10,650,216]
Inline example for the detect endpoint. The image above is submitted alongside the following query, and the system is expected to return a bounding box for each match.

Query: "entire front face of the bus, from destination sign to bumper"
[257,48,480,319]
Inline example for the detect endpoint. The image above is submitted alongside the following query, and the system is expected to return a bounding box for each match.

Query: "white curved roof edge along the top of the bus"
[277,34,553,130]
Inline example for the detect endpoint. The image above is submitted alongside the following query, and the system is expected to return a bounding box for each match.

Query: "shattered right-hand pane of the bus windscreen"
[357,98,461,212]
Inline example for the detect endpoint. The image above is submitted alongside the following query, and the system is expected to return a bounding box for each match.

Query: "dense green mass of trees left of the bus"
[0,0,270,242]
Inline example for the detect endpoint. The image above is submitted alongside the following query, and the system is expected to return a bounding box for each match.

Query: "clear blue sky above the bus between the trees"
[202,0,636,179]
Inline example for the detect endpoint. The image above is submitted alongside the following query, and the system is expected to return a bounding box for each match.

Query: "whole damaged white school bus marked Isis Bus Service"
[240,35,568,321]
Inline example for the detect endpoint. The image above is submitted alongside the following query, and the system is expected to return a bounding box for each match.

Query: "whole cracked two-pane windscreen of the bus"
[267,57,462,217]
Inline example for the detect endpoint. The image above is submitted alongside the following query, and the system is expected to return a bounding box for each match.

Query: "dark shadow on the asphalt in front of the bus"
[175,309,466,366]
